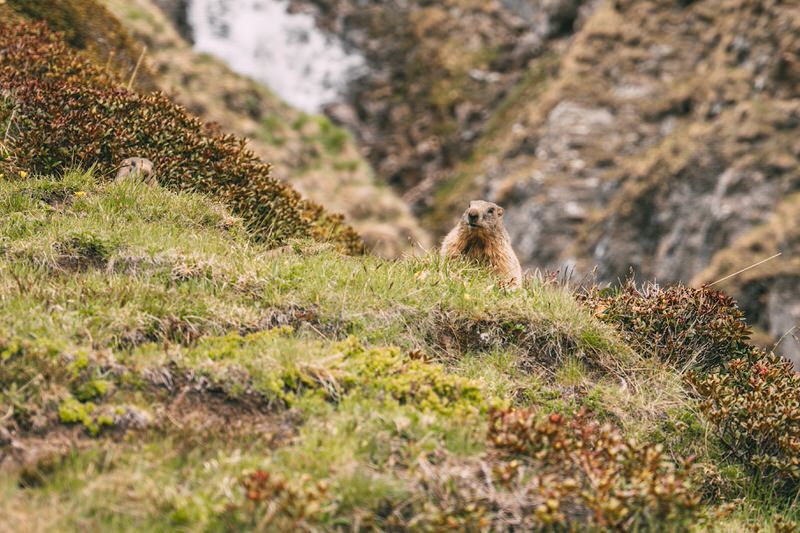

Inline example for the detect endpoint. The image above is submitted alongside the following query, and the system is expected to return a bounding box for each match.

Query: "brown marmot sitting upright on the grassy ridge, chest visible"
[441,200,522,287]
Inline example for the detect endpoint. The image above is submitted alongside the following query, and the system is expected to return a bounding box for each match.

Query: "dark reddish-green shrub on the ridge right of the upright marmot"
[581,281,750,370]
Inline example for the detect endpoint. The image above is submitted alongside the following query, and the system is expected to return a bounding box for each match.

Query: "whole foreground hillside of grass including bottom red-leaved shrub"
[0,168,798,531]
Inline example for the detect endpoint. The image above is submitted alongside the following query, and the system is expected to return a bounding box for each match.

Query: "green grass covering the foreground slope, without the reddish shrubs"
[0,171,792,531]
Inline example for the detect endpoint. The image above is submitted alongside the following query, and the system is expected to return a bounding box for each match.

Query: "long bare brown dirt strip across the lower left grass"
[0,369,302,488]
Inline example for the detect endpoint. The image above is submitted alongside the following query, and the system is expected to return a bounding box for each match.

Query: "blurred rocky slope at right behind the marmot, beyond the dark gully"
[428,0,800,357]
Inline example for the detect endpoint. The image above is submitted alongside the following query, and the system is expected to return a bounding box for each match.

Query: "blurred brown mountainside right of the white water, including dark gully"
[144,0,800,360]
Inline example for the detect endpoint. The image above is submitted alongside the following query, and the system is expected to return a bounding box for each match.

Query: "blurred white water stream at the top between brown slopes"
[189,0,365,113]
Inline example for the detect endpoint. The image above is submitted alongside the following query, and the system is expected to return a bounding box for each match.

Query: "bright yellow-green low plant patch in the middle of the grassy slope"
[178,334,487,416]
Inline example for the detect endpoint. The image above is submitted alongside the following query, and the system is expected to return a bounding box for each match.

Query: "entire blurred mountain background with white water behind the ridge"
[67,0,800,361]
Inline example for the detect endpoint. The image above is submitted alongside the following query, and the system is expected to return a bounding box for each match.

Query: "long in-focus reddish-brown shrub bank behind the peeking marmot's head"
[0,20,363,253]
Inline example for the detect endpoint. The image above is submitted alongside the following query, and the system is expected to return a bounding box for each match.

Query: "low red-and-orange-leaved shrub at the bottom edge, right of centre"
[488,409,699,531]
